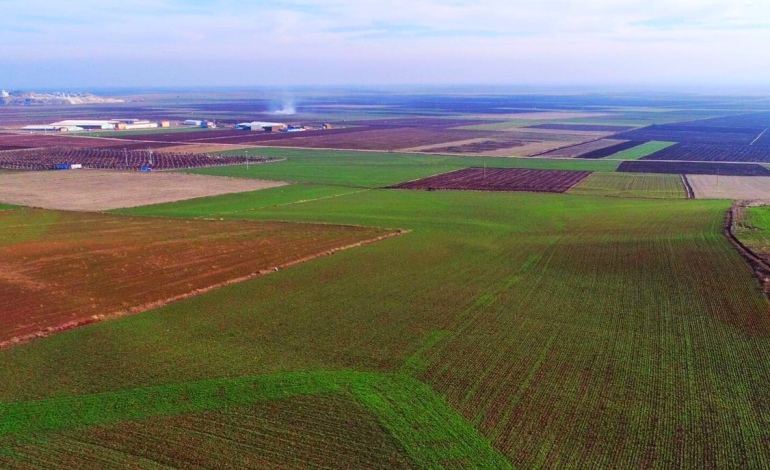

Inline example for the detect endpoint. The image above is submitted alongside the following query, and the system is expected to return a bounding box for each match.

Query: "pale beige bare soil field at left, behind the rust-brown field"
[0,170,287,211]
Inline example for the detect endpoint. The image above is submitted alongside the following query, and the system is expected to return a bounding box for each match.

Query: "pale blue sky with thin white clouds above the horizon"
[0,0,770,90]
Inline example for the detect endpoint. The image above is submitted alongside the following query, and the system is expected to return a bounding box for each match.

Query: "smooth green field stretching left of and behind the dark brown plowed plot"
[188,148,618,188]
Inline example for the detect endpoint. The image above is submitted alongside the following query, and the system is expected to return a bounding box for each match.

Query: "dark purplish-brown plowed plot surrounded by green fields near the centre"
[390,168,591,193]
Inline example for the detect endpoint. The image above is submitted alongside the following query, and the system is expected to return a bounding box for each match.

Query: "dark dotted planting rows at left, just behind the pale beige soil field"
[0,147,276,170]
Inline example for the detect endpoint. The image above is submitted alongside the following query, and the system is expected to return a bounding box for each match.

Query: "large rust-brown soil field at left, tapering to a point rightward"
[0,209,396,347]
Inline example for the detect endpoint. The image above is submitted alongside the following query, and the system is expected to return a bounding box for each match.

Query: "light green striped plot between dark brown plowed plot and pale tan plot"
[567,173,686,199]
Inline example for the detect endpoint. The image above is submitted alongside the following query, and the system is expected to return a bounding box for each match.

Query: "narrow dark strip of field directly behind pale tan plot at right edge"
[617,160,770,176]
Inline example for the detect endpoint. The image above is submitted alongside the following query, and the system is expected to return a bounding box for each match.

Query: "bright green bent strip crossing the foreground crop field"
[0,370,511,469]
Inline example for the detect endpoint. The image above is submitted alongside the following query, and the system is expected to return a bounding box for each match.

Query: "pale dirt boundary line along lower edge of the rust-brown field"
[0,229,409,350]
